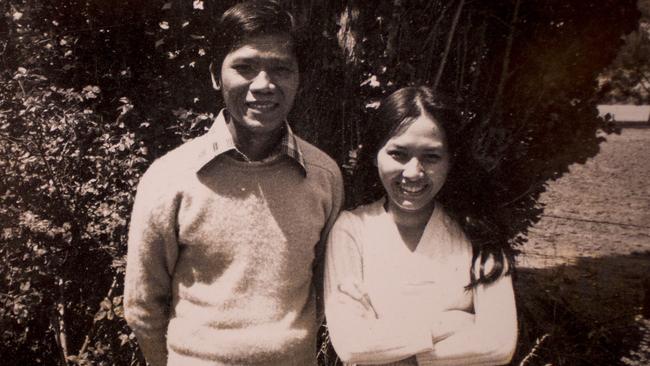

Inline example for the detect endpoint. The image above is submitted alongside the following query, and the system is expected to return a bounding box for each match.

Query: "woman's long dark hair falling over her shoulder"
[359,86,514,288]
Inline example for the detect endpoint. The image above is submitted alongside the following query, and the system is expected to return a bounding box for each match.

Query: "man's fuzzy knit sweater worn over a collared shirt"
[124,127,343,366]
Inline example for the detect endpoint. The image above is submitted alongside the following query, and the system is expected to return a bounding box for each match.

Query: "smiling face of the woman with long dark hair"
[377,114,449,213]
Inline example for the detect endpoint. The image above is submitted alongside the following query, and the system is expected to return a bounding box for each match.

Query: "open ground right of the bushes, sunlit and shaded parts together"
[516,128,650,366]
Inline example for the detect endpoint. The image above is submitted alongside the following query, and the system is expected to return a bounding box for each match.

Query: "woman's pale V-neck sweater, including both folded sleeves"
[325,199,517,365]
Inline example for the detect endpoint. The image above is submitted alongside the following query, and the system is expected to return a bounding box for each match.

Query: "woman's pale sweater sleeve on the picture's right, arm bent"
[418,258,517,366]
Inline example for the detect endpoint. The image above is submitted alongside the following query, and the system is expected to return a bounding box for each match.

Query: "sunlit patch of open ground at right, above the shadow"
[519,128,650,268]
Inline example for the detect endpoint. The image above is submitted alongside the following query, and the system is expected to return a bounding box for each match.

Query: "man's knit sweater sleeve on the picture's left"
[124,168,178,366]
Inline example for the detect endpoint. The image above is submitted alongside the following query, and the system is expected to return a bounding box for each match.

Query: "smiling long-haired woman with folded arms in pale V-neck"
[325,87,517,365]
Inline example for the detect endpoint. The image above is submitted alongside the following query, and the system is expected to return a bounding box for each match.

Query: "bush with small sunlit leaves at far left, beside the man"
[0,68,147,364]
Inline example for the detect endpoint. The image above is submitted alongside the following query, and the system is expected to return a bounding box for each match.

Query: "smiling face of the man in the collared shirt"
[220,34,299,134]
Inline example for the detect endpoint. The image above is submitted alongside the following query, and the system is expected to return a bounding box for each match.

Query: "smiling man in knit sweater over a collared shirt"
[125,1,343,366]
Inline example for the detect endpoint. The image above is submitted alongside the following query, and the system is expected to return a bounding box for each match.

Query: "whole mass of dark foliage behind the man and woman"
[0,0,637,365]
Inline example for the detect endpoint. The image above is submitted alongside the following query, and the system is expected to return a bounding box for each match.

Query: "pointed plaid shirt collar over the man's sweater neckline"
[196,109,307,175]
